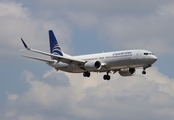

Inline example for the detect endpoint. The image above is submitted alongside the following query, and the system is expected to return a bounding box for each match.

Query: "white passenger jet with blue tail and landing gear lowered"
[21,30,157,80]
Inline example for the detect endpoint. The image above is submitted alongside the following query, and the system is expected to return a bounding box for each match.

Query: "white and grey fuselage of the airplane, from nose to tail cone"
[48,50,157,73]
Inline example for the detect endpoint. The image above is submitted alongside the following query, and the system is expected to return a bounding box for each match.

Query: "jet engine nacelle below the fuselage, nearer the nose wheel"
[119,68,135,76]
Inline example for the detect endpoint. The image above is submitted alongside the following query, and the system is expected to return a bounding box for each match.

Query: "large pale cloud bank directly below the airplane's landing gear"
[2,68,174,120]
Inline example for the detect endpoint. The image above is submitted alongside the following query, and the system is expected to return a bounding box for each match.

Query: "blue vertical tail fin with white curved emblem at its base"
[49,30,63,56]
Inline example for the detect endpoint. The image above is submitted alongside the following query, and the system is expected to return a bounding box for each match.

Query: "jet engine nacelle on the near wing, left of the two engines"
[84,61,101,71]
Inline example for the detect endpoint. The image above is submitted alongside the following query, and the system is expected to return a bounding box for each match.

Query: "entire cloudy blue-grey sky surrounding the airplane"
[0,0,174,120]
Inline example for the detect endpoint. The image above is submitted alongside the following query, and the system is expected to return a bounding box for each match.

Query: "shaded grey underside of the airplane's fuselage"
[51,58,150,73]
